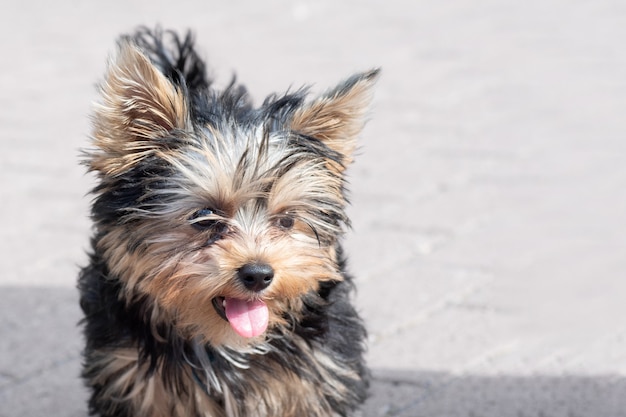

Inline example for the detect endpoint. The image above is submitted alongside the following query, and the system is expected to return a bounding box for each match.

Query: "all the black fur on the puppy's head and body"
[78,28,368,417]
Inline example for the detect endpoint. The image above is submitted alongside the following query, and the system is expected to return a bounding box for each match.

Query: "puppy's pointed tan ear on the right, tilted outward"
[291,69,379,172]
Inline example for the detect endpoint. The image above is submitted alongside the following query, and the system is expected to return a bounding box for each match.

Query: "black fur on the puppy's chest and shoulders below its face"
[79,247,369,417]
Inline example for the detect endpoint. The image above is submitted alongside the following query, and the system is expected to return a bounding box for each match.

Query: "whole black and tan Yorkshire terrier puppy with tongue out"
[79,29,378,417]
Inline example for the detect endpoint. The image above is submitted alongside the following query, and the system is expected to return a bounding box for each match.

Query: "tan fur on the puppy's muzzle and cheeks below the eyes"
[95,180,342,346]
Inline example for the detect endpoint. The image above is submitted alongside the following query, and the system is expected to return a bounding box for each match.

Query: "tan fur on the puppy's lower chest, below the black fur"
[91,341,356,417]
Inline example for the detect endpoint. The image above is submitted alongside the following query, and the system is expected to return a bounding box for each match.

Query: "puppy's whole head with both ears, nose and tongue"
[87,43,376,346]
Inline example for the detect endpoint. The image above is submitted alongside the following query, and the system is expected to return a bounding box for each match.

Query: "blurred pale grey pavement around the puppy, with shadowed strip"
[0,0,626,417]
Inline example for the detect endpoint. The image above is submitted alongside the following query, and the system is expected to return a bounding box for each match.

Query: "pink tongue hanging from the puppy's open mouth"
[225,298,269,337]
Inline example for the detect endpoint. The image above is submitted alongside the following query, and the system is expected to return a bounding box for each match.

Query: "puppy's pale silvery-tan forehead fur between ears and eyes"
[168,124,340,214]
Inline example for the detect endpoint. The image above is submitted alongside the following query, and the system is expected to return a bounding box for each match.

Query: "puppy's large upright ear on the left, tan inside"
[87,40,190,175]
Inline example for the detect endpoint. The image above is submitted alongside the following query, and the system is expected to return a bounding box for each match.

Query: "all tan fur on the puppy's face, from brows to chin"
[91,111,345,346]
